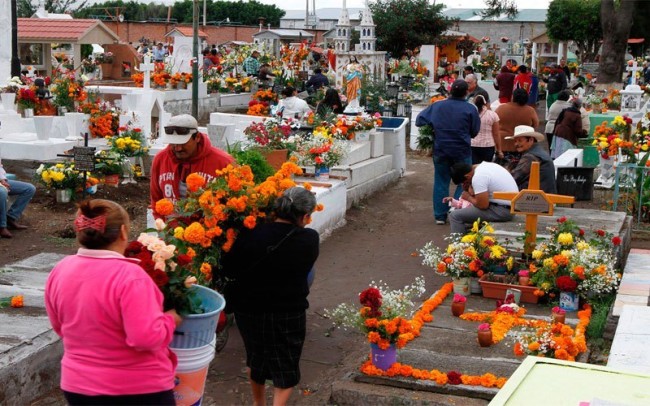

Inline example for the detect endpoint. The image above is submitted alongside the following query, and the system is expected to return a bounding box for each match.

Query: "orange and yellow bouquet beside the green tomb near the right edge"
[593,116,636,162]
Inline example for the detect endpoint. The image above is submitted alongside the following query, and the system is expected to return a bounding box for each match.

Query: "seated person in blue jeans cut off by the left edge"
[0,156,36,238]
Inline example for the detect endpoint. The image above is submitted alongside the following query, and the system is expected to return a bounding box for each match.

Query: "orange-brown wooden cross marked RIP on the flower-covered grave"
[493,162,575,254]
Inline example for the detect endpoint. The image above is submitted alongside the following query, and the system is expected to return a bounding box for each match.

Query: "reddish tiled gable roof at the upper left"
[18,18,119,44]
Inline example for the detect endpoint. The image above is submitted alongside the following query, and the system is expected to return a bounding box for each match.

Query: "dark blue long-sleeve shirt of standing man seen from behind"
[415,97,481,160]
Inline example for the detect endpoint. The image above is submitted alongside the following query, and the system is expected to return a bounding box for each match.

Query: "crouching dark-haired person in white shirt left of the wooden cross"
[449,161,519,234]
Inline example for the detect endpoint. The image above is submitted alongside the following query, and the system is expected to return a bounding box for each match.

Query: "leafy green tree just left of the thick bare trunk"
[546,0,603,62]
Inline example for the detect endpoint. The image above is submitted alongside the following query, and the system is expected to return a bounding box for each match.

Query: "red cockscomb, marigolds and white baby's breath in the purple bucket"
[325,276,425,350]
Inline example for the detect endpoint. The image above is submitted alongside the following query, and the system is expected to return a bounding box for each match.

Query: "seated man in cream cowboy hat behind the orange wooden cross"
[506,125,557,193]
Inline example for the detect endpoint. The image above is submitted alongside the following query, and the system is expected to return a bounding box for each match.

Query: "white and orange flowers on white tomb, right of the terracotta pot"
[291,129,349,168]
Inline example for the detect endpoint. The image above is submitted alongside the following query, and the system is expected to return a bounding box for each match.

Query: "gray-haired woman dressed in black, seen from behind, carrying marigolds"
[223,187,319,405]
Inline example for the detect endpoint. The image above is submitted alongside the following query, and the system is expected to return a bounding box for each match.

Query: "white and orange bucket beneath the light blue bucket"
[170,336,217,406]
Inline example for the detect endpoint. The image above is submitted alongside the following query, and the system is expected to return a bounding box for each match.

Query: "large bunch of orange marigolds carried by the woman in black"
[154,162,306,282]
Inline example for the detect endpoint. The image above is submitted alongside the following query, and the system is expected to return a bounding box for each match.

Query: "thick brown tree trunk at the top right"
[598,0,636,83]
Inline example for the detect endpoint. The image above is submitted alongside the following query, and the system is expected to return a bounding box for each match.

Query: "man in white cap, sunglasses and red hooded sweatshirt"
[150,114,235,211]
